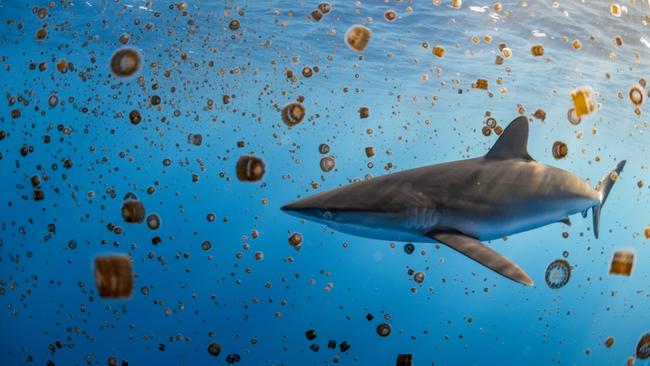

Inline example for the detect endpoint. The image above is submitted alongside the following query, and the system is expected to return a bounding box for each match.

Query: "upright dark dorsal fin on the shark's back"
[485,116,534,160]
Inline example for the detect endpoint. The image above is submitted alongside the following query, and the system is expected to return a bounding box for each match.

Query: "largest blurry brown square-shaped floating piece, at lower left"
[95,255,133,299]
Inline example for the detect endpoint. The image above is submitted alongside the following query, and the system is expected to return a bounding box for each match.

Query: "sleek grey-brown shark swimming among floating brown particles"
[282,117,625,286]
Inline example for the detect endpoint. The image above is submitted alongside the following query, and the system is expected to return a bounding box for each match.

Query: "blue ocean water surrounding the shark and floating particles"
[0,0,650,366]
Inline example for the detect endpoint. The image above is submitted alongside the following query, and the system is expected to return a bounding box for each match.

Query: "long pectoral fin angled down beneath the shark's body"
[427,232,533,286]
